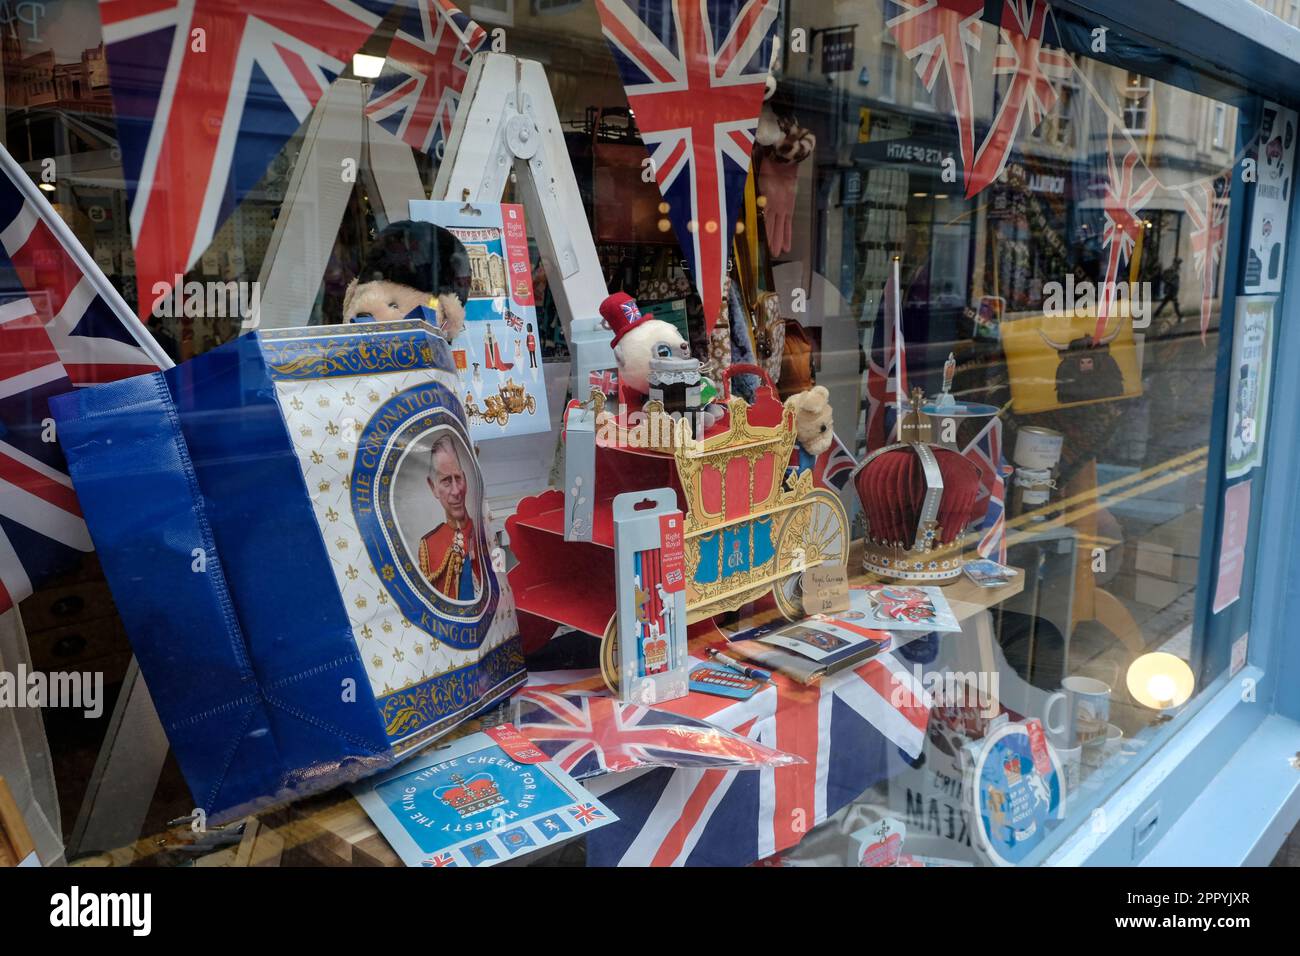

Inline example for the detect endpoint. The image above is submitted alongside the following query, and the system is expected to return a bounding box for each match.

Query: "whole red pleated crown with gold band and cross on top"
[853,389,980,583]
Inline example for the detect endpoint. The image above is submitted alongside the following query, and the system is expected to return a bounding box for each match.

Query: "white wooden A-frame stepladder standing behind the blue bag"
[68,53,614,857]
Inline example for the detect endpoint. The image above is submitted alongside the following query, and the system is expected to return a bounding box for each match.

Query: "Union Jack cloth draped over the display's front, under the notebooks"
[529,642,931,866]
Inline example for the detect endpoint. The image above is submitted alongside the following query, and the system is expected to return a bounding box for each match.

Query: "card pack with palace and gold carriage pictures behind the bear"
[411,200,551,442]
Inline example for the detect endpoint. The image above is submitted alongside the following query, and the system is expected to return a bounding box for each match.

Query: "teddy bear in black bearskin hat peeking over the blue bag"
[343,220,469,341]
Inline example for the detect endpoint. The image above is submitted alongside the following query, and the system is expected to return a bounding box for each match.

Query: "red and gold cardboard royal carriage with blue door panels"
[506,361,849,688]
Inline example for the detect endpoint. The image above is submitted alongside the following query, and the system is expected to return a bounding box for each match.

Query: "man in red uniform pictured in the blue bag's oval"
[417,434,484,601]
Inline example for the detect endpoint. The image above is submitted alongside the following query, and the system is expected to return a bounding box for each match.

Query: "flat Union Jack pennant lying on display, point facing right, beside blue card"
[515,689,789,780]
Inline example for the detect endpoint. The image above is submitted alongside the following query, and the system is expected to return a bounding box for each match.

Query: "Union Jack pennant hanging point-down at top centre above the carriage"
[595,0,780,332]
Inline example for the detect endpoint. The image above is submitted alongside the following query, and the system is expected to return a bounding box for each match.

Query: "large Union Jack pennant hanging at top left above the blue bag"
[99,0,393,321]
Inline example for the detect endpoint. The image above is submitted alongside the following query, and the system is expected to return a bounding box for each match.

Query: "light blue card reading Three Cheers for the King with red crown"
[354,724,618,866]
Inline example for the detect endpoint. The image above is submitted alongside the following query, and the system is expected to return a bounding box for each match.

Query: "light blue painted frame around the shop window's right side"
[1050,0,1300,865]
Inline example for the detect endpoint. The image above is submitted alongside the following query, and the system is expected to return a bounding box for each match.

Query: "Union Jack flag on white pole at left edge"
[0,147,170,610]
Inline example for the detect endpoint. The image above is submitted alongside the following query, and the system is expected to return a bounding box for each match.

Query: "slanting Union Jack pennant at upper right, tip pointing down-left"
[953,0,1074,199]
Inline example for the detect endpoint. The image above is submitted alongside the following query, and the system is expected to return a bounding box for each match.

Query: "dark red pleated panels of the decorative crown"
[857,445,980,546]
